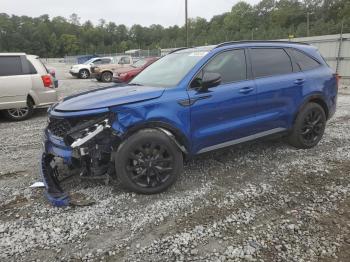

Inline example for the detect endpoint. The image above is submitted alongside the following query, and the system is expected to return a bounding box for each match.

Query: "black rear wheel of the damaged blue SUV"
[288,103,327,149]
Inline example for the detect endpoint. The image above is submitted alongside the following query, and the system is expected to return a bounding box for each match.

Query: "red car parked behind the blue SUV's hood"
[113,57,159,83]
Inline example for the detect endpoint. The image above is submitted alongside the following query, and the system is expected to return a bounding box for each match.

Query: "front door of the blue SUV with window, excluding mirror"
[188,49,256,153]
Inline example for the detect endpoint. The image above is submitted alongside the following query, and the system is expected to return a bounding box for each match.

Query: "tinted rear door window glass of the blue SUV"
[251,48,293,77]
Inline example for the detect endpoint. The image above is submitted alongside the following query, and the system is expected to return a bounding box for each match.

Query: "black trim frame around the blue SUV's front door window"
[187,47,253,90]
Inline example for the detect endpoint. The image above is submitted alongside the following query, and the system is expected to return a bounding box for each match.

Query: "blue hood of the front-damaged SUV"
[54,86,165,112]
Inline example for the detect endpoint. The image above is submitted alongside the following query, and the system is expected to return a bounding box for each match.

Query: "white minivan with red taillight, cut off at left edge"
[0,53,58,121]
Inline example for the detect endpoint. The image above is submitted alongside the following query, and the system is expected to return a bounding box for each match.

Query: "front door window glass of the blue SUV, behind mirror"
[203,50,247,84]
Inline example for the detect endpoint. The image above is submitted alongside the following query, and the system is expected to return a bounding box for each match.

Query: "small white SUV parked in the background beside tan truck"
[69,57,113,79]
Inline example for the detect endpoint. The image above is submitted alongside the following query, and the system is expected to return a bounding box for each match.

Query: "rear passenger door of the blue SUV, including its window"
[249,47,305,133]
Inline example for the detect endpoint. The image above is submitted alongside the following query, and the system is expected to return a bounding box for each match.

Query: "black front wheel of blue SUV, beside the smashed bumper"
[115,129,183,194]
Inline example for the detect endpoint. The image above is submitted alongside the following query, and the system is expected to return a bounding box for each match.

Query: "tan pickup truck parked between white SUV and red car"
[92,56,134,82]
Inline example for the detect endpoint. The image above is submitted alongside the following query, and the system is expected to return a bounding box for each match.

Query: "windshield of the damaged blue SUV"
[130,49,208,87]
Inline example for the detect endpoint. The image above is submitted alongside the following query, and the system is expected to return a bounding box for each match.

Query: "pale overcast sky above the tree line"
[0,0,259,27]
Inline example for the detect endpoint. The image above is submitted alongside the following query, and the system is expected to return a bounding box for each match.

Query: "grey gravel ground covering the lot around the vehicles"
[0,64,350,262]
